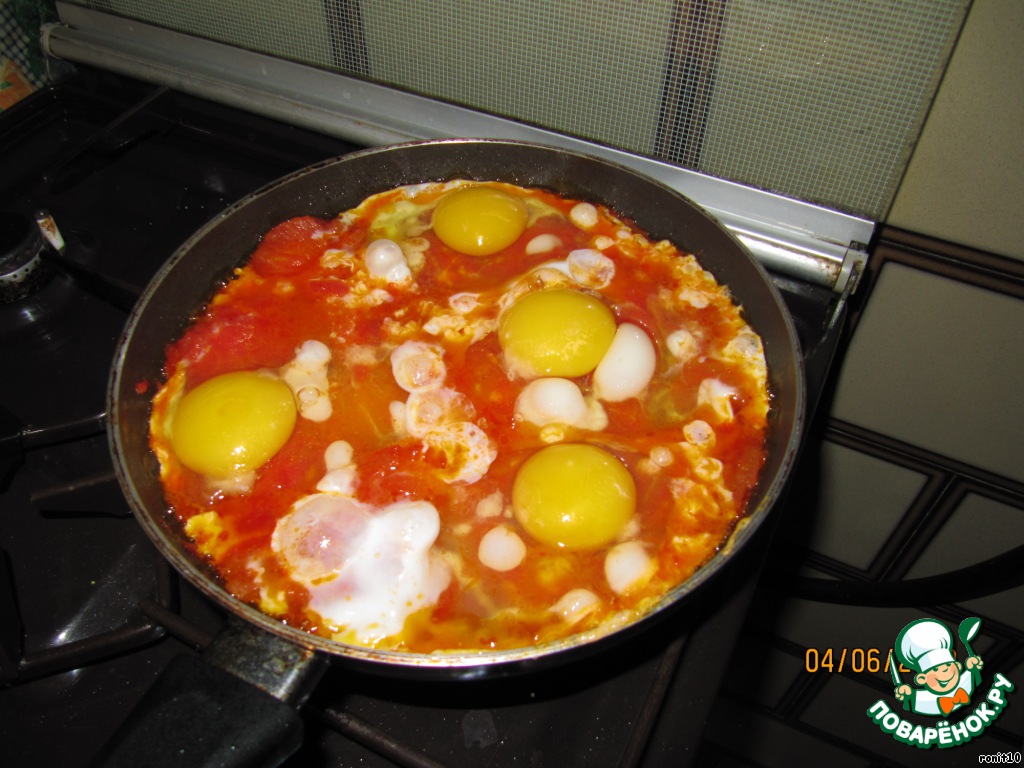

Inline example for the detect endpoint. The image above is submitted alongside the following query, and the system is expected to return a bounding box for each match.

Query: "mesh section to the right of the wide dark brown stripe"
[699,0,965,214]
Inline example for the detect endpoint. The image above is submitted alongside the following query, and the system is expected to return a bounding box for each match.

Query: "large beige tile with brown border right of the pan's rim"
[833,263,1024,481]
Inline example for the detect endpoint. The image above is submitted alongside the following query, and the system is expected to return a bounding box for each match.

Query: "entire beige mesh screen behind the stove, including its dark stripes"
[70,0,970,218]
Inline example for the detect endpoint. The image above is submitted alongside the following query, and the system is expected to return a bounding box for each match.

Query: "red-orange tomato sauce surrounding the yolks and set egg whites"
[151,185,768,652]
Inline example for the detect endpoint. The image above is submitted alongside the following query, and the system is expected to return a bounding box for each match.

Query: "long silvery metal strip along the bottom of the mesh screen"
[43,2,874,292]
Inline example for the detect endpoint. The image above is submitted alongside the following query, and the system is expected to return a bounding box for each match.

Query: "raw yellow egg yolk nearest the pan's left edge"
[171,371,296,478]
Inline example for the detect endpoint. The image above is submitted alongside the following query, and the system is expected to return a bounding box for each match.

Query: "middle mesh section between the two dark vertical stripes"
[361,0,672,154]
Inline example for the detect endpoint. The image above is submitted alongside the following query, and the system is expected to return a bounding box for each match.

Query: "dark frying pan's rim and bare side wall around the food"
[108,139,805,761]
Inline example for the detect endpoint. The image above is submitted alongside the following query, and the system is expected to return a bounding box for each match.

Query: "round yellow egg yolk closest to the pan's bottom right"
[512,443,637,550]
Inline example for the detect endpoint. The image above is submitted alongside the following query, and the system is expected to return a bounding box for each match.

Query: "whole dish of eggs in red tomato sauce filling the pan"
[150,180,769,653]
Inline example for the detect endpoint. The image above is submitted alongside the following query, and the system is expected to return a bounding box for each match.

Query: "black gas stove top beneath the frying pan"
[0,67,845,766]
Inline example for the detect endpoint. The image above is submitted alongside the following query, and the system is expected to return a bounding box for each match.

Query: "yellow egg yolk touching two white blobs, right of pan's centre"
[498,290,615,378]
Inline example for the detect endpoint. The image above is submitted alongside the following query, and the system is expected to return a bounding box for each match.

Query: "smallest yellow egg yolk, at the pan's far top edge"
[432,186,526,256]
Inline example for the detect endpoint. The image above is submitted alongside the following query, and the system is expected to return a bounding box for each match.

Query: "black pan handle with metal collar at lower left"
[93,617,327,768]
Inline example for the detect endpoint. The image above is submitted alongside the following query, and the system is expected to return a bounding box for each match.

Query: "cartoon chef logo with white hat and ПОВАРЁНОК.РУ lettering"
[867,618,1014,749]
